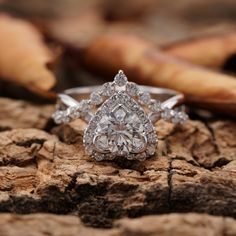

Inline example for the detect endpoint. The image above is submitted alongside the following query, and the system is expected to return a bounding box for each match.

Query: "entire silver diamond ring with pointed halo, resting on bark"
[53,70,188,161]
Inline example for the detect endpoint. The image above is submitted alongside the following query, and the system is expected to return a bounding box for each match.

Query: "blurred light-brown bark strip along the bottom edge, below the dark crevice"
[0,213,236,236]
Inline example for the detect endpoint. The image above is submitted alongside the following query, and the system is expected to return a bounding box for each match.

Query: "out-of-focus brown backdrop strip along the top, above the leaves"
[0,0,236,45]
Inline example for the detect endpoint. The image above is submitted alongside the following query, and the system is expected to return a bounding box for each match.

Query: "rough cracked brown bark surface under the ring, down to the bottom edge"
[0,98,236,235]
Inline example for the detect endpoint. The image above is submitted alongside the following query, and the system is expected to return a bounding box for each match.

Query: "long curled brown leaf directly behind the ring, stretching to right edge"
[84,35,236,115]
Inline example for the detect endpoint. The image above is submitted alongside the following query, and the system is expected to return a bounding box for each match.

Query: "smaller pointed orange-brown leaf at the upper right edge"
[164,31,236,68]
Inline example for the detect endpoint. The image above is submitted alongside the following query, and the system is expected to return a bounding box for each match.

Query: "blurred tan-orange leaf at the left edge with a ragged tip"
[0,15,56,95]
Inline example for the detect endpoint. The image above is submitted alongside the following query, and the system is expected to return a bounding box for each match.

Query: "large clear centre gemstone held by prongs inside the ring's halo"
[94,105,147,156]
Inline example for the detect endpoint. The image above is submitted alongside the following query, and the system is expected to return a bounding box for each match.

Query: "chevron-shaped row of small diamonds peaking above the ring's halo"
[53,70,188,124]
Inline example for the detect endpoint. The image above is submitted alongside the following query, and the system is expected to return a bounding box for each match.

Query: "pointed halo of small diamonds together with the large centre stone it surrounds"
[84,91,157,160]
